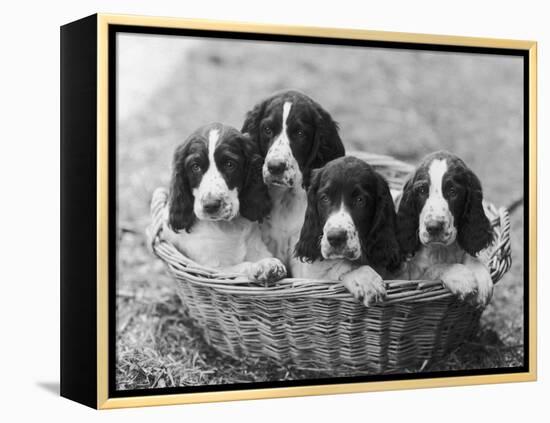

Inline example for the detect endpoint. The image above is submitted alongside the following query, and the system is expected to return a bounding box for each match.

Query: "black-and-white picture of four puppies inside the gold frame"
[112,29,528,394]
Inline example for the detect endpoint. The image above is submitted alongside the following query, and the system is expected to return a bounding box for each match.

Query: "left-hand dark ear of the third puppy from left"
[294,169,323,263]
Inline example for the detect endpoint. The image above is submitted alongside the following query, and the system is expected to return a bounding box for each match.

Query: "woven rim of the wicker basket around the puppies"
[148,152,511,305]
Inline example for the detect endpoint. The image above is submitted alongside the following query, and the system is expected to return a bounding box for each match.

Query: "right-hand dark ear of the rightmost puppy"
[457,168,493,256]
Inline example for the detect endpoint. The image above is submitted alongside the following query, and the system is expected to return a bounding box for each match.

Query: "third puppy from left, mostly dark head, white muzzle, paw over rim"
[294,156,399,305]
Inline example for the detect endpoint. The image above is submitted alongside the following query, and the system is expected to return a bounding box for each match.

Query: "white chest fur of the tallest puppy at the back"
[261,186,307,265]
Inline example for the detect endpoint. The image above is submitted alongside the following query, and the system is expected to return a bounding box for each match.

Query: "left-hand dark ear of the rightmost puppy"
[397,175,420,256]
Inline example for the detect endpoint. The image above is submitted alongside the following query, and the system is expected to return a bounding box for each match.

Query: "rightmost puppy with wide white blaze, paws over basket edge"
[397,151,493,305]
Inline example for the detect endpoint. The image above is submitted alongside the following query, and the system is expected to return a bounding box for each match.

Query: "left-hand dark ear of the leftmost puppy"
[168,144,196,232]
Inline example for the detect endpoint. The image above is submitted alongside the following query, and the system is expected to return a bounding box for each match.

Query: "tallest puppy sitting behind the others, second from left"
[242,91,345,272]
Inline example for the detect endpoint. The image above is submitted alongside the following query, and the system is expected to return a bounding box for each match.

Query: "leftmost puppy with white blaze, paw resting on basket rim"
[161,123,286,282]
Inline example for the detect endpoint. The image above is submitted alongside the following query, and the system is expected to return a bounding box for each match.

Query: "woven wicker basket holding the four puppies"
[151,153,511,372]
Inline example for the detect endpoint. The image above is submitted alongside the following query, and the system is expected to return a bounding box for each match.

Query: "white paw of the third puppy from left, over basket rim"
[340,266,386,307]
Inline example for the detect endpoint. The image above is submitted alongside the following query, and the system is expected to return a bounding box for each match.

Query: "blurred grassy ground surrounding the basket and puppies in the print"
[116,34,524,389]
